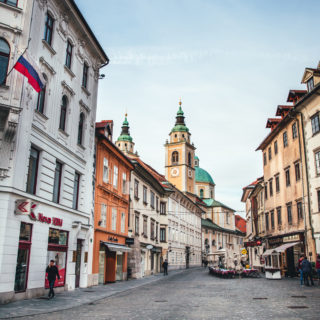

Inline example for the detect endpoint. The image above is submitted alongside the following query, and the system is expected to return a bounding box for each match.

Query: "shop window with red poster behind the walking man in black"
[45,228,69,288]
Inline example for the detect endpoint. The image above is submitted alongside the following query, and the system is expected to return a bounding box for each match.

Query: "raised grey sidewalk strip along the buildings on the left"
[0,268,194,319]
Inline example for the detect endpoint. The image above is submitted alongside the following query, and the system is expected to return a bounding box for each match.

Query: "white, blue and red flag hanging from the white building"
[14,54,45,92]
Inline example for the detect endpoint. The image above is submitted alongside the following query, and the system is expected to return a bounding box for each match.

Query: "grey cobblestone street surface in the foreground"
[2,269,320,320]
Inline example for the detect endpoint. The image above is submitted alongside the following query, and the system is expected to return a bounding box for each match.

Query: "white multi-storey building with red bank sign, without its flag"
[0,0,108,303]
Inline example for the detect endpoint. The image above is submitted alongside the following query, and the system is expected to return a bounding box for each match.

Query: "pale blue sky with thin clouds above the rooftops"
[76,0,320,215]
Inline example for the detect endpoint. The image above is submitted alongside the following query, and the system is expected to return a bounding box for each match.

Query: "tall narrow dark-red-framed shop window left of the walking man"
[14,222,32,292]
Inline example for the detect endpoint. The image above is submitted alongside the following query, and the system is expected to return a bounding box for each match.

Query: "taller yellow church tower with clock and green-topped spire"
[165,101,196,194]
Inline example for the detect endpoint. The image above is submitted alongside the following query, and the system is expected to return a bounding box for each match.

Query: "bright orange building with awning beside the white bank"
[92,121,133,284]
